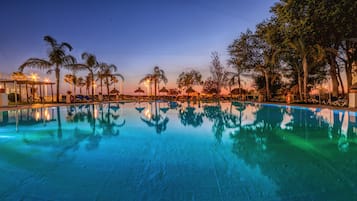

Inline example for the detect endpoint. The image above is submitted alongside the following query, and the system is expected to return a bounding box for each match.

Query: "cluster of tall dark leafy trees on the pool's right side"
[228,0,357,102]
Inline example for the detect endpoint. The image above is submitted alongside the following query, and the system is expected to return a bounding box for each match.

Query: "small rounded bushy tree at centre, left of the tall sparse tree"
[177,70,203,94]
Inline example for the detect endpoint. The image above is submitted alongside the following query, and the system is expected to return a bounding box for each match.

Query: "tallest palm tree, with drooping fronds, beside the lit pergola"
[19,36,76,103]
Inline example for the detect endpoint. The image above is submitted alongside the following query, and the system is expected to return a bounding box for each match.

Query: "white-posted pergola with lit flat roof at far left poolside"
[0,80,55,104]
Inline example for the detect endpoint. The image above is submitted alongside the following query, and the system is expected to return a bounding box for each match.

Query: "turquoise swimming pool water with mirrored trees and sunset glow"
[0,102,357,201]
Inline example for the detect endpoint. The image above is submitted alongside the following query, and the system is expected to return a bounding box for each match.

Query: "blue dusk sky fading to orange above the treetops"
[0,0,276,93]
